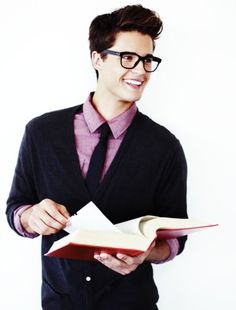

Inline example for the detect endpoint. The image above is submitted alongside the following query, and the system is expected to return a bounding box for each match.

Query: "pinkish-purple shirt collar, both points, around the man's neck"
[83,94,137,139]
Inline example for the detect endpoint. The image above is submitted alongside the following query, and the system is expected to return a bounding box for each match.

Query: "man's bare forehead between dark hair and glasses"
[112,31,153,55]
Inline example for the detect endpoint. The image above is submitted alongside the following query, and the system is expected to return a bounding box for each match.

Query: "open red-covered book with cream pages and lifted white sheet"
[45,202,217,260]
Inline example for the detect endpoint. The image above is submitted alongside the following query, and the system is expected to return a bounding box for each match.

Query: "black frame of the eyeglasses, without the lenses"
[101,49,162,73]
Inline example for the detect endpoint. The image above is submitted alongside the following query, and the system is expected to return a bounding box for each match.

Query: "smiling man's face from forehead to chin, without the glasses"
[95,31,153,103]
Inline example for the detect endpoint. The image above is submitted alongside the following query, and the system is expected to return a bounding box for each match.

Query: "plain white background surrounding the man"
[0,0,236,310]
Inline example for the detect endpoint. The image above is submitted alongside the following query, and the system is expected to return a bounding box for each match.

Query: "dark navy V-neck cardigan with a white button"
[6,106,187,310]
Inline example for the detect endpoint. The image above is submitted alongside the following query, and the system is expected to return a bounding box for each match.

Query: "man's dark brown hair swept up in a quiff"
[89,4,163,75]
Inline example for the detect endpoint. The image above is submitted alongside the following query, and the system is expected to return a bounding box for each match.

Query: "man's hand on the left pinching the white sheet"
[21,199,70,235]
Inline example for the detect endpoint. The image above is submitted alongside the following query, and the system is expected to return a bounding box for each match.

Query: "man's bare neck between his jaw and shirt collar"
[92,91,133,121]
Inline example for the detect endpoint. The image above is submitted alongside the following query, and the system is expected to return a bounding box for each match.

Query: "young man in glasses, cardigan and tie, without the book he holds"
[7,5,187,310]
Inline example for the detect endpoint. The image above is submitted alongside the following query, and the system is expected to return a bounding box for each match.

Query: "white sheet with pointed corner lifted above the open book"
[64,201,120,233]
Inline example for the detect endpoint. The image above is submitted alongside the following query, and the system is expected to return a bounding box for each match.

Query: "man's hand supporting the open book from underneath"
[94,242,155,275]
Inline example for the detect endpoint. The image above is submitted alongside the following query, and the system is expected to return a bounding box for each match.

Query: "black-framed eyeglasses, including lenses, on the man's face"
[101,50,161,72]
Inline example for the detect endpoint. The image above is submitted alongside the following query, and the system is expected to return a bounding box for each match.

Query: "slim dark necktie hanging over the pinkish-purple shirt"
[86,123,111,195]
